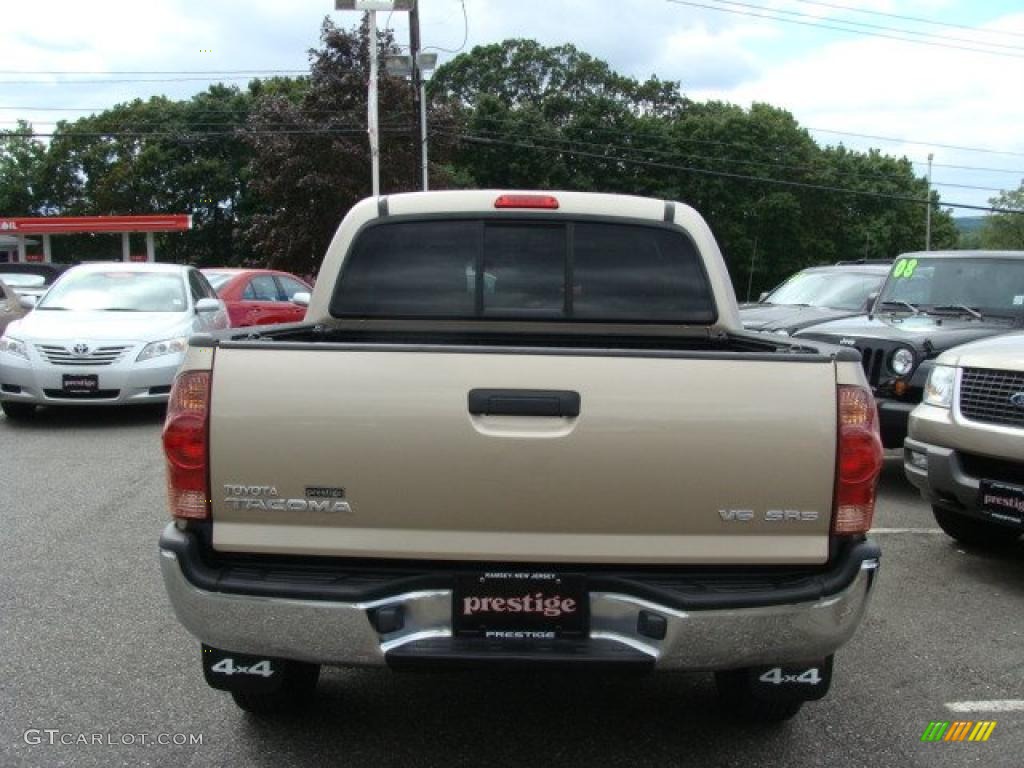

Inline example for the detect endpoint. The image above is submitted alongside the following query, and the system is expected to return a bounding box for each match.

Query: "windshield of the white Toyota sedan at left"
[38,269,188,312]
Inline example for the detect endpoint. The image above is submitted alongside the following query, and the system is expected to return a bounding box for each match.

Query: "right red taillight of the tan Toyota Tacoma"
[833,384,883,536]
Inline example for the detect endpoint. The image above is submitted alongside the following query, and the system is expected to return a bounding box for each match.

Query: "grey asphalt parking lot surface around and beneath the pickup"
[0,409,1024,768]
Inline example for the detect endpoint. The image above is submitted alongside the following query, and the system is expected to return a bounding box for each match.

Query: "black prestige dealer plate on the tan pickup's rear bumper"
[452,570,590,640]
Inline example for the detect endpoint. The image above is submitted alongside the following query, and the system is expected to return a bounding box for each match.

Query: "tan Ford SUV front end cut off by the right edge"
[903,333,1024,547]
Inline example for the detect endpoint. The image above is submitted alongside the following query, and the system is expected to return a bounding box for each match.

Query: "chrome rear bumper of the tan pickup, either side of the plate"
[160,528,879,670]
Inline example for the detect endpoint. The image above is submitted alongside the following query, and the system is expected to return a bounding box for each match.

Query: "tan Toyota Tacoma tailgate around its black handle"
[210,345,837,564]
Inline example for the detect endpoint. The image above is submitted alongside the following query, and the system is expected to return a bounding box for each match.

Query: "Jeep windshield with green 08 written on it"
[878,257,1024,314]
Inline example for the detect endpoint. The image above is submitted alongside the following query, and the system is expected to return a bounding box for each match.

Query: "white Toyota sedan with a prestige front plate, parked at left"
[0,262,228,419]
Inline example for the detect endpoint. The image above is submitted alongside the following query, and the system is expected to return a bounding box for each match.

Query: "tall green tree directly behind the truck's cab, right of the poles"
[430,40,689,194]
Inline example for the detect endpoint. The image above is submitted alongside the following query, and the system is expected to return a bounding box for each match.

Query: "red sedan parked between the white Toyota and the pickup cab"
[202,267,312,328]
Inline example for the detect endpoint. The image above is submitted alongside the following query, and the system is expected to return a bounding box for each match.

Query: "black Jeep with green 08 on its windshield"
[795,251,1024,449]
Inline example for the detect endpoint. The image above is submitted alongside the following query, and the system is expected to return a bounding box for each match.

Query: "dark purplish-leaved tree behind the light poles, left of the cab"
[246,19,456,273]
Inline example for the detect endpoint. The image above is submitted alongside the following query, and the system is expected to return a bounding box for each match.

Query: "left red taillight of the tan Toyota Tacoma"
[164,371,210,520]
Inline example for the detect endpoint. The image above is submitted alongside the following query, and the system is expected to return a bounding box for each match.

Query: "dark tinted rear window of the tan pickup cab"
[331,219,716,325]
